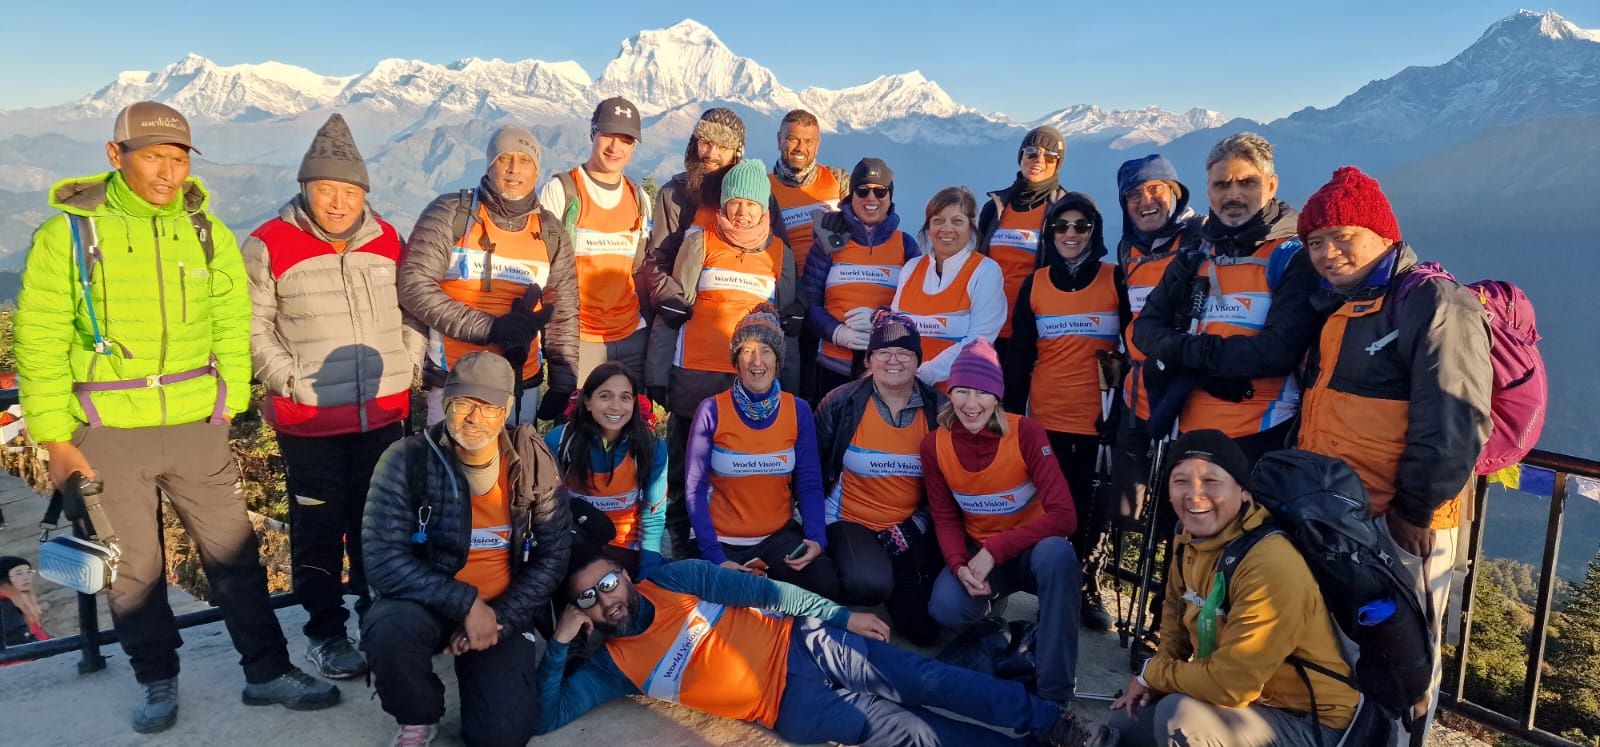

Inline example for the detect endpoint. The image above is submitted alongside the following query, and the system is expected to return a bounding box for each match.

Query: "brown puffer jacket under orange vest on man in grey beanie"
[400,187,578,392]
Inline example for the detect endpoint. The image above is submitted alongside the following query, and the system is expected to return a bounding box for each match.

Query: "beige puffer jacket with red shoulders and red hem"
[243,197,427,437]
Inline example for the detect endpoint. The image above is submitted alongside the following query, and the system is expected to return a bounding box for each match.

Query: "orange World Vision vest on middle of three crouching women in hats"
[827,398,928,531]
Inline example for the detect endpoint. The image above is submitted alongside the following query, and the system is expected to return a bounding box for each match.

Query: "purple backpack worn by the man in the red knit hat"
[1395,262,1550,475]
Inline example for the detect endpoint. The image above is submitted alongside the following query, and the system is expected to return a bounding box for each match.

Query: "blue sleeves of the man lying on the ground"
[538,560,850,734]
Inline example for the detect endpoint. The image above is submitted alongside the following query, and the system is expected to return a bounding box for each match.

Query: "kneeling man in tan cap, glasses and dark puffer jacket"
[362,352,571,745]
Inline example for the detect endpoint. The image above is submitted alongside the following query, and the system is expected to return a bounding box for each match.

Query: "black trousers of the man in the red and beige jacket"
[278,422,403,640]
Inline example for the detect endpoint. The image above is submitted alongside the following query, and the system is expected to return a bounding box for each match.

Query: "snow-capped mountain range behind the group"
[0,11,1600,467]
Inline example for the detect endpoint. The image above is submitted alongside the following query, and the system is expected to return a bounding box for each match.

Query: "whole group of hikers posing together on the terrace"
[6,91,1490,745]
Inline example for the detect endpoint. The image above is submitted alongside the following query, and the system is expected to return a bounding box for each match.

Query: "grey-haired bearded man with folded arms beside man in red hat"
[1133,133,1317,464]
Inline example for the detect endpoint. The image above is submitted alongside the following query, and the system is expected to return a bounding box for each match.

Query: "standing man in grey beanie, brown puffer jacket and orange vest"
[400,125,578,424]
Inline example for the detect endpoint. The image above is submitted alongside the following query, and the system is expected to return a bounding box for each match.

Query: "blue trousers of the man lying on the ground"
[773,619,1061,747]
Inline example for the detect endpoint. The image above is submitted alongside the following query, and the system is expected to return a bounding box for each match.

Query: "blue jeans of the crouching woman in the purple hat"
[928,537,1083,702]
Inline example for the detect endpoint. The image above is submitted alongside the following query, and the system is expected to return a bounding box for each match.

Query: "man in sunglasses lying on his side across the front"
[538,545,1114,745]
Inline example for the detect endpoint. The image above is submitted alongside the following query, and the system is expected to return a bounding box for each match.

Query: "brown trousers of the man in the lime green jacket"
[72,422,290,683]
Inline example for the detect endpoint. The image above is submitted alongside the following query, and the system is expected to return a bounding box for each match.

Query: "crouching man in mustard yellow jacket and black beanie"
[1112,430,1360,747]
